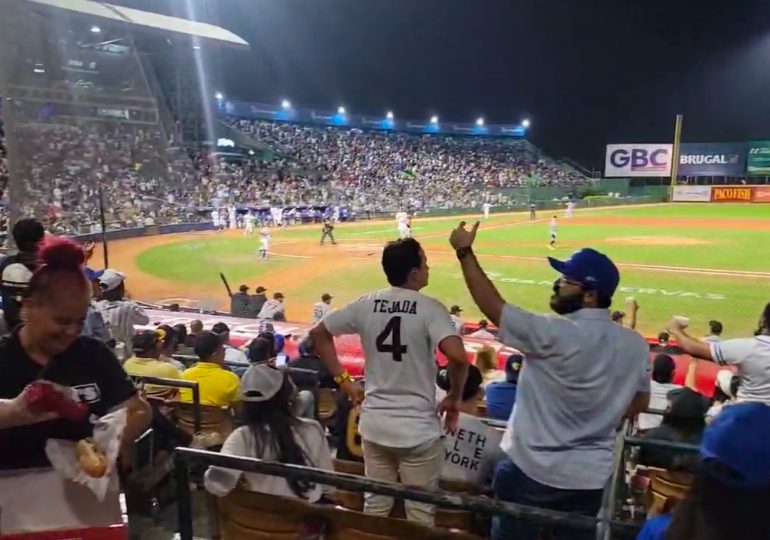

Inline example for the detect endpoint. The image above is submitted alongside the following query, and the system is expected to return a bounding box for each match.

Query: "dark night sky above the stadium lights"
[136,0,770,168]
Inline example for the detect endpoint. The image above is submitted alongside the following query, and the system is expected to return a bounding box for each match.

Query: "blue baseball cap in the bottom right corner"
[700,402,770,489]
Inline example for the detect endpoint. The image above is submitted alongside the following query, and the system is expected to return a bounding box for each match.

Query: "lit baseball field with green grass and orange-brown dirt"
[106,203,770,336]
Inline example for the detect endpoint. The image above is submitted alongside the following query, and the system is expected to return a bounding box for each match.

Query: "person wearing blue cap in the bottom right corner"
[637,403,770,540]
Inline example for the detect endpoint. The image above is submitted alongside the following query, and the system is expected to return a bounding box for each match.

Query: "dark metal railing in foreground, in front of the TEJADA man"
[174,448,639,540]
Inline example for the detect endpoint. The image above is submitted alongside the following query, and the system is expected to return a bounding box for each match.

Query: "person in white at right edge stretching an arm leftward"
[669,303,770,405]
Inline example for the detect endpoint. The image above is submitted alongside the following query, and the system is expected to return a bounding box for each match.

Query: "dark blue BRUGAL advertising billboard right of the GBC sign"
[679,143,746,176]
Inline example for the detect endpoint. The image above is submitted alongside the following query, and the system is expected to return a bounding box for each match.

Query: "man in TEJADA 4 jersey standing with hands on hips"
[310,238,468,524]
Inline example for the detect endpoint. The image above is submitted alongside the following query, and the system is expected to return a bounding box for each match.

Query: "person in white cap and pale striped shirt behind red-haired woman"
[97,269,150,359]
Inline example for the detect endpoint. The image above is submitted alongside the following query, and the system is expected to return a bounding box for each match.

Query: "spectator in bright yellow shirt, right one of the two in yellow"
[179,331,241,409]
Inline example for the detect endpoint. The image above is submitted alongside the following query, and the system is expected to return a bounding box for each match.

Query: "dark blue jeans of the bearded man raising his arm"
[491,456,603,540]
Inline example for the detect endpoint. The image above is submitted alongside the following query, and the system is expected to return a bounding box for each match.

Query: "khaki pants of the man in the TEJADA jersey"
[363,439,444,526]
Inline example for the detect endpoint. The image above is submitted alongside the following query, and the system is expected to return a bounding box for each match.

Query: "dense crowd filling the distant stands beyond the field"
[0,103,585,235]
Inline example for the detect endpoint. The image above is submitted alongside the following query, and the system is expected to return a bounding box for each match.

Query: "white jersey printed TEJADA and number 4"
[323,287,458,448]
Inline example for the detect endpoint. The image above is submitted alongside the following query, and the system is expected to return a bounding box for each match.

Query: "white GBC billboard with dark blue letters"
[604,144,671,178]
